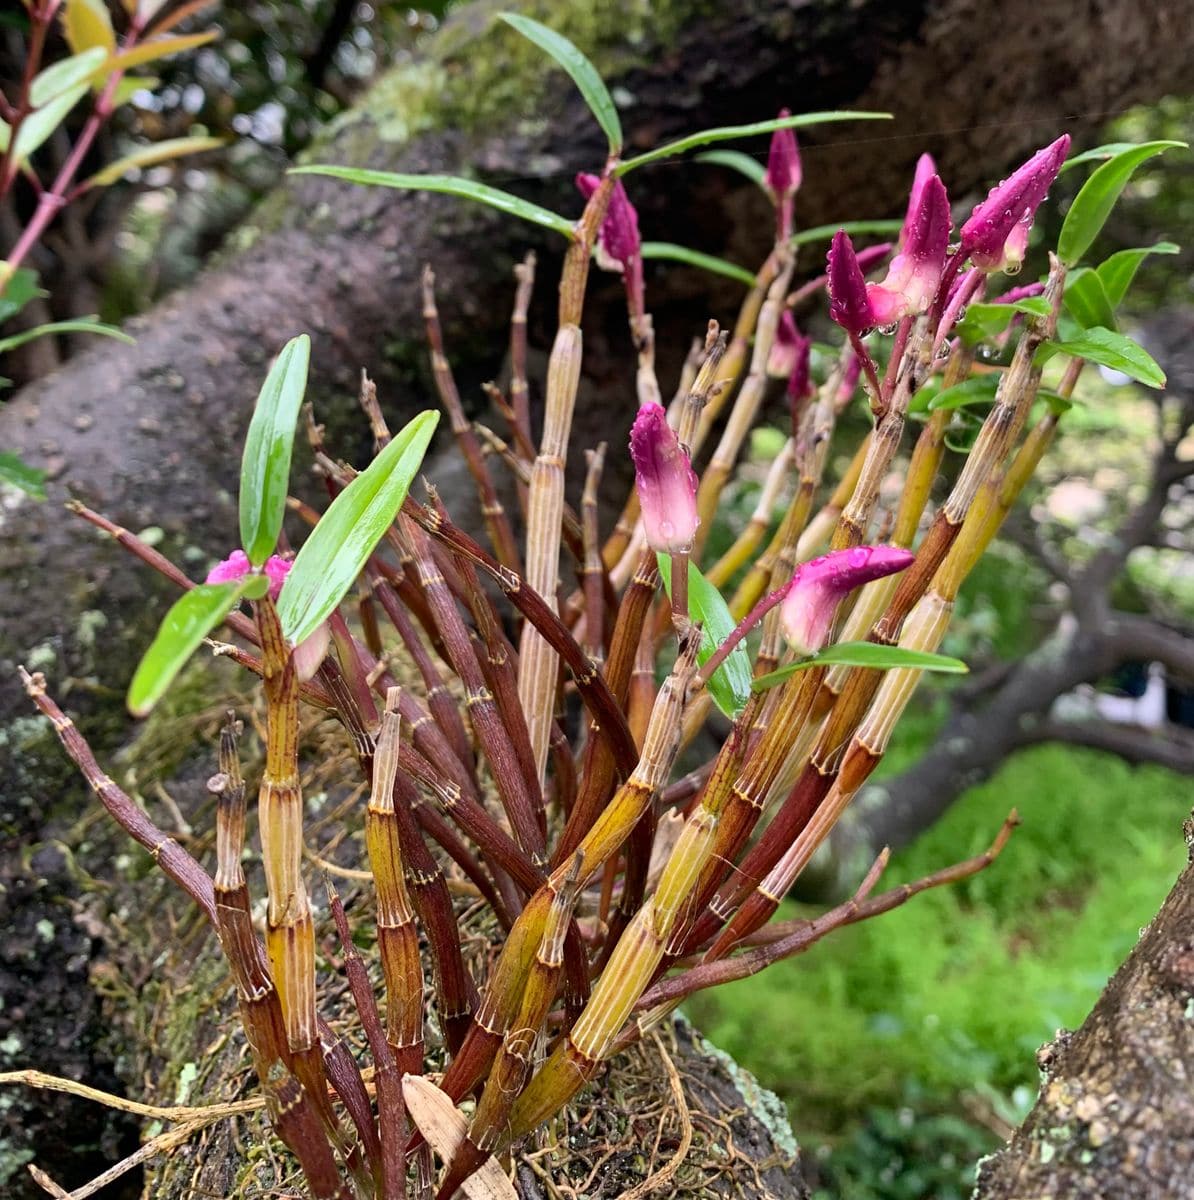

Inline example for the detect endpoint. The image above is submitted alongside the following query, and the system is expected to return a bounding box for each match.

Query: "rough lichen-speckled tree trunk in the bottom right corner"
[974,822,1194,1200]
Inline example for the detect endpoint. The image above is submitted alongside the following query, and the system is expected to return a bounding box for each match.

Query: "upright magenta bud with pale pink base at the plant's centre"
[630,404,697,554]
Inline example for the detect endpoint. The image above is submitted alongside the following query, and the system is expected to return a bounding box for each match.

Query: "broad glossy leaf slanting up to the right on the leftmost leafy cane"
[277,410,439,646]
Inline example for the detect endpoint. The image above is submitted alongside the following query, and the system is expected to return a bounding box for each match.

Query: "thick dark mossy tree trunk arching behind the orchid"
[0,0,1192,1195]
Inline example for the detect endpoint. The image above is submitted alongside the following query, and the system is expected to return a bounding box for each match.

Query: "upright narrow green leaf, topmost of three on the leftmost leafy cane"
[240,334,311,566]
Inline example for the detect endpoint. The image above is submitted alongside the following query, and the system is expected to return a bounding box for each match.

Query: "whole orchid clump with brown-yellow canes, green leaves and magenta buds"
[14,9,1180,1200]
